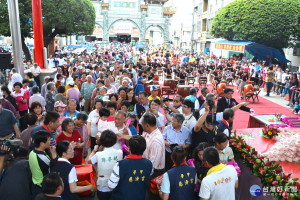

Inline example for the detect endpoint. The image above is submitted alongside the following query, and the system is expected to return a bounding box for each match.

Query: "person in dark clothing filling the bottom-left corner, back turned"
[0,145,32,200]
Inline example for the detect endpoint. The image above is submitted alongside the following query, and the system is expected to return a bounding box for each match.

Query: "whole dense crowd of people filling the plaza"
[0,44,290,200]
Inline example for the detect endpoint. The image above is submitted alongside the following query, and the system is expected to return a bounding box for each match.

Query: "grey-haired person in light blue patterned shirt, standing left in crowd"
[80,75,95,113]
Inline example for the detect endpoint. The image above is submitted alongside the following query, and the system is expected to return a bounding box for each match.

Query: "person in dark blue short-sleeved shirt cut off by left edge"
[0,96,20,139]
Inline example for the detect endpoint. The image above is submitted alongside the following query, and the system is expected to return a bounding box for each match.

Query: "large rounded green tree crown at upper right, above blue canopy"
[210,0,300,51]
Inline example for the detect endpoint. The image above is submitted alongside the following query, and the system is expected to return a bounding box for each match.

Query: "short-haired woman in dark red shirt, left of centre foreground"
[56,118,84,165]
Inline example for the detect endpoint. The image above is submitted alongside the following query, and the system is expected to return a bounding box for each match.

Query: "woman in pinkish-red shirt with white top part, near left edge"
[11,82,29,131]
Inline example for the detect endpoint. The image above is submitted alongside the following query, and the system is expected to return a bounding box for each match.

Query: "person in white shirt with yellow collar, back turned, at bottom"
[199,147,238,200]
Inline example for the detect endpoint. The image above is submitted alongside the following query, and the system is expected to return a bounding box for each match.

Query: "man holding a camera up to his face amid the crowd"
[163,95,183,126]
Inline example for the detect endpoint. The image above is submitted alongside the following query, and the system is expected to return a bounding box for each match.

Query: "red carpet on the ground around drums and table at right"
[162,84,296,129]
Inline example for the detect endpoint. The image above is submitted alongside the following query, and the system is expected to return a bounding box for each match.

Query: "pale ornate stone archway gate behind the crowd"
[90,0,175,44]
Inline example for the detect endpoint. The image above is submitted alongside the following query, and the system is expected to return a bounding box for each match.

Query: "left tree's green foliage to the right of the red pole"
[42,0,96,46]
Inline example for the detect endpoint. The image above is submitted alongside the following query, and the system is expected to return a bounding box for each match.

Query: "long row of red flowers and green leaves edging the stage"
[230,133,300,200]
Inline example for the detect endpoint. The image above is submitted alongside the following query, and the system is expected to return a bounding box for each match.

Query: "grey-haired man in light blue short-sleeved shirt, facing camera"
[163,113,191,170]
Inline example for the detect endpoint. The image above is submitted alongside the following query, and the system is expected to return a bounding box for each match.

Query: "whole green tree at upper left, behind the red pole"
[0,0,96,60]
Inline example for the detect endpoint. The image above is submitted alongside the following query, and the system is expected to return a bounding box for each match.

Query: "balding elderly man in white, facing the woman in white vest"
[108,110,132,149]
